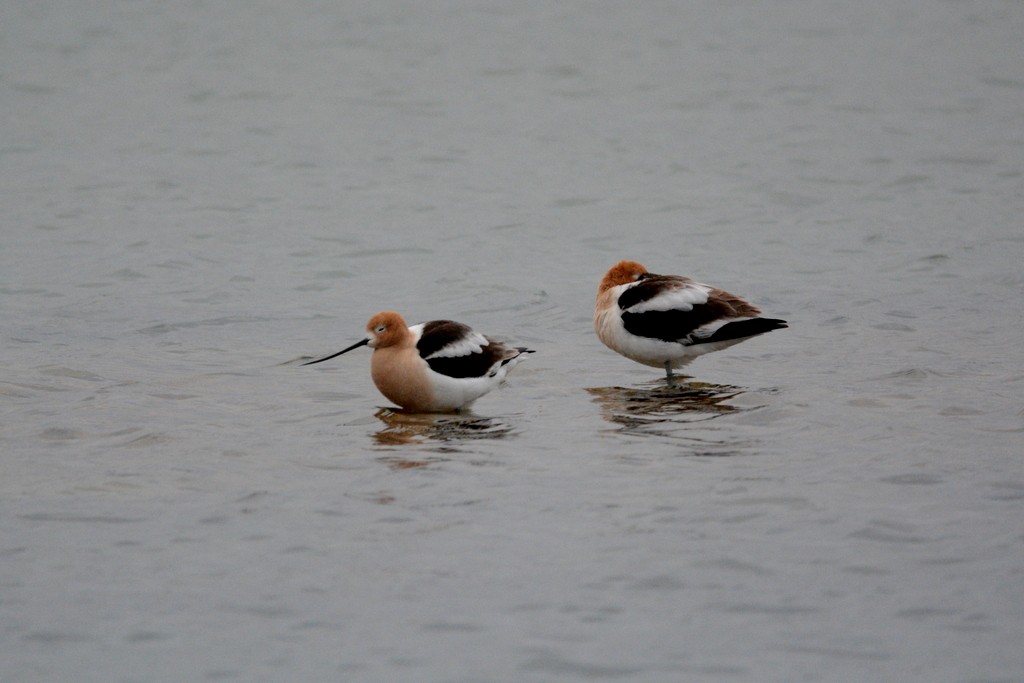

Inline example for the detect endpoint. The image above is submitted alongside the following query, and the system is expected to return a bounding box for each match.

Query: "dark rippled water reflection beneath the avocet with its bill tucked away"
[587,376,744,431]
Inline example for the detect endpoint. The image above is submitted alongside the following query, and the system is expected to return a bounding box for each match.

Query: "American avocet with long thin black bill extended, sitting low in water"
[302,310,534,413]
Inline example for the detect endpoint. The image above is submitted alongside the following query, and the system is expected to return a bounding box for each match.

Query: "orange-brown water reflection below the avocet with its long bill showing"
[374,408,512,456]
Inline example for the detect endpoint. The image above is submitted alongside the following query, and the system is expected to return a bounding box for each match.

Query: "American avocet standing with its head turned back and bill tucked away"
[594,261,787,379]
